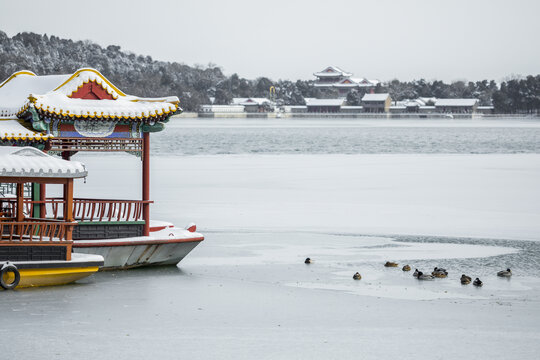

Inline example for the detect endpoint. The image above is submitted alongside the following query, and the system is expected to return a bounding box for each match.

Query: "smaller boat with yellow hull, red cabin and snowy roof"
[0,147,103,289]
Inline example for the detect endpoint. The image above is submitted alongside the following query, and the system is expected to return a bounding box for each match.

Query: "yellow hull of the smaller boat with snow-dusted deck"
[0,254,104,289]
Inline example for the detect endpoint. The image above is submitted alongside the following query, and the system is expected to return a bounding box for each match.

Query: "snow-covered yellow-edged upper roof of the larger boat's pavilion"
[0,68,179,119]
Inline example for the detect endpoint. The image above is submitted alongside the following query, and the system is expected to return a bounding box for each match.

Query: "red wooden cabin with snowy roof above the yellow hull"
[0,147,87,261]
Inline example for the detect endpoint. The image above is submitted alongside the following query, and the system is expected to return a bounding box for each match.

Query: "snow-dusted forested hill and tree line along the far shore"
[0,31,540,113]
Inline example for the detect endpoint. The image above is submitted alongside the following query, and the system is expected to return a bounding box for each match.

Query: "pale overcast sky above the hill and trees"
[0,0,540,81]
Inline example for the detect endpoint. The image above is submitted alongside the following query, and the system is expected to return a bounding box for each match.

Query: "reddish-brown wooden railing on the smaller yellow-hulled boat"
[0,218,77,244]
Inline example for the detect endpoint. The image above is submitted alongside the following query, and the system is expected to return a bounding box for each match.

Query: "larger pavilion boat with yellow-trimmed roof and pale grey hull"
[0,68,204,269]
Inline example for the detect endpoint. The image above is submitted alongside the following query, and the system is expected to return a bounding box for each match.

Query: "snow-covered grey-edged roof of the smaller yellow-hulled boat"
[0,146,88,178]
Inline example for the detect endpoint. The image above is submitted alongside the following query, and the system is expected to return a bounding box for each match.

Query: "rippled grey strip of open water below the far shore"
[152,119,540,155]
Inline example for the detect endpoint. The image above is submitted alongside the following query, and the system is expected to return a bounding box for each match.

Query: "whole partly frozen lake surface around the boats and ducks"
[4,119,540,359]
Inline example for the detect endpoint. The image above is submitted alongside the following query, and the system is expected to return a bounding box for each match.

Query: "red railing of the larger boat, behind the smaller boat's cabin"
[0,198,153,221]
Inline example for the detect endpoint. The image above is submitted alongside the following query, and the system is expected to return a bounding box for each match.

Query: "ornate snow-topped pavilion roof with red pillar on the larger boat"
[0,68,180,235]
